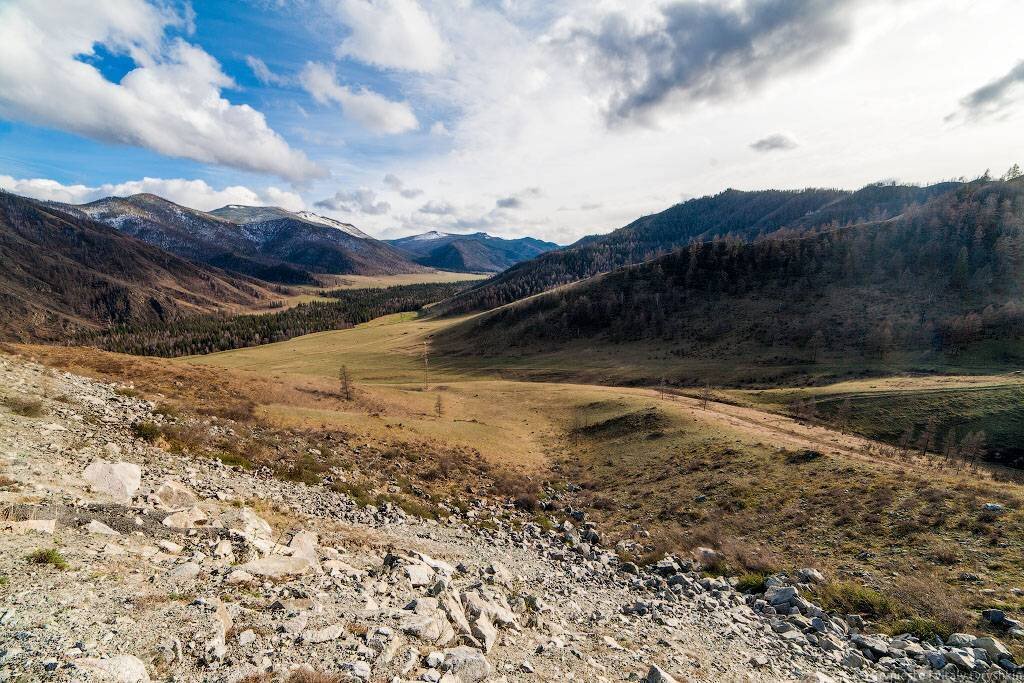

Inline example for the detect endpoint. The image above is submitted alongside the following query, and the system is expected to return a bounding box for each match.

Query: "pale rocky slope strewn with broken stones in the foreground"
[0,356,1019,683]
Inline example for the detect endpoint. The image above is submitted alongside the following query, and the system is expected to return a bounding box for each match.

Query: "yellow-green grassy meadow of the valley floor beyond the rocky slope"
[14,305,1024,647]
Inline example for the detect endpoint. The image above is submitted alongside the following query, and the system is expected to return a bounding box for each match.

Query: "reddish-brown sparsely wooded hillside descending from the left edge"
[0,193,269,340]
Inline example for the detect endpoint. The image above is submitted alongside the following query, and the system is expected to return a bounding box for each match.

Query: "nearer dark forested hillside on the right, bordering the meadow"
[438,179,1024,368]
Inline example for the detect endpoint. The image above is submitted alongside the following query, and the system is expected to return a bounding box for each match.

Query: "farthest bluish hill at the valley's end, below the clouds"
[387,230,558,272]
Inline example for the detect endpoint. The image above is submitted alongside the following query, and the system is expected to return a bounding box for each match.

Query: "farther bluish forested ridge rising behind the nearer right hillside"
[445,183,958,313]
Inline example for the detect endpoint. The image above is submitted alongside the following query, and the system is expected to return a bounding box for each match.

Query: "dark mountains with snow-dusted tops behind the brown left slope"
[52,194,423,284]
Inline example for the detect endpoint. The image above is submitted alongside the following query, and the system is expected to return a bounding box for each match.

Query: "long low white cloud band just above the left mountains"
[0,175,305,211]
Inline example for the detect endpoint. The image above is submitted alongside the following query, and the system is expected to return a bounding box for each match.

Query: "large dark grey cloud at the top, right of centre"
[569,0,862,123]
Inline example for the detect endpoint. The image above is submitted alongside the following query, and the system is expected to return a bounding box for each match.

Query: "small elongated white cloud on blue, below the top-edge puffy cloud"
[299,61,420,135]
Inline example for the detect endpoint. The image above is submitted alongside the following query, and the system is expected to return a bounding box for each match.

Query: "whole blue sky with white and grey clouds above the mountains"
[0,0,1024,244]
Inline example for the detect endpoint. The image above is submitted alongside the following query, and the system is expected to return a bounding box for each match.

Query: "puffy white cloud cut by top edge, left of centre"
[328,0,445,73]
